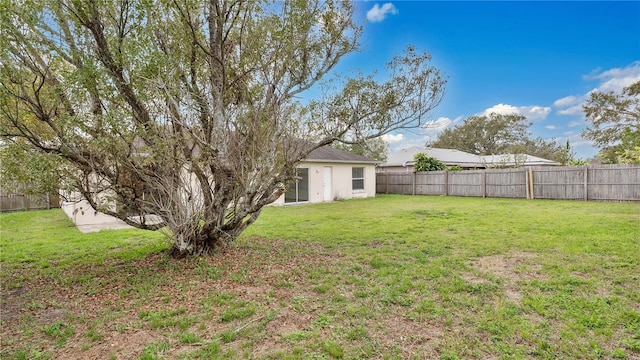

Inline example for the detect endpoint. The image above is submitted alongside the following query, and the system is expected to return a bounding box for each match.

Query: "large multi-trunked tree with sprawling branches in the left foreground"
[0,0,445,256]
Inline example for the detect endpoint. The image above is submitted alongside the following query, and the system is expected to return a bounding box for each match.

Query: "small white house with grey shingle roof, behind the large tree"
[274,146,379,205]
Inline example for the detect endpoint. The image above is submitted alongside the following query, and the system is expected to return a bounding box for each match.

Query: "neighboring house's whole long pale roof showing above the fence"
[376,146,561,172]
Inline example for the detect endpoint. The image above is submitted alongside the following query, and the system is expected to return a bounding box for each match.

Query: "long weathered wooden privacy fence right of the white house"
[376,165,640,201]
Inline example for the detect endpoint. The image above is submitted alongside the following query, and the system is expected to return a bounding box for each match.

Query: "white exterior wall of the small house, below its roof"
[273,162,376,205]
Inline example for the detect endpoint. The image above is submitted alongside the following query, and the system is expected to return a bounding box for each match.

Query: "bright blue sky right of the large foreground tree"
[340,1,640,158]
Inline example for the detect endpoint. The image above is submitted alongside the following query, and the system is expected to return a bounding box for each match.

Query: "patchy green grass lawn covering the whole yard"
[0,195,640,359]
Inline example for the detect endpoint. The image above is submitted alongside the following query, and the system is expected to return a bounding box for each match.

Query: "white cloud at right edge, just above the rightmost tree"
[553,61,640,115]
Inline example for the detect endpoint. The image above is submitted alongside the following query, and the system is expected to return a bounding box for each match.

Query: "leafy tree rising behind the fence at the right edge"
[582,81,640,162]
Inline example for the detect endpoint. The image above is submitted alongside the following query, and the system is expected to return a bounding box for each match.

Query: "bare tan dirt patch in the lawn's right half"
[462,252,544,304]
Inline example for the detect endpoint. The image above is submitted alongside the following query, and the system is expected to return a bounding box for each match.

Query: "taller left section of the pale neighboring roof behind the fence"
[380,146,485,167]
